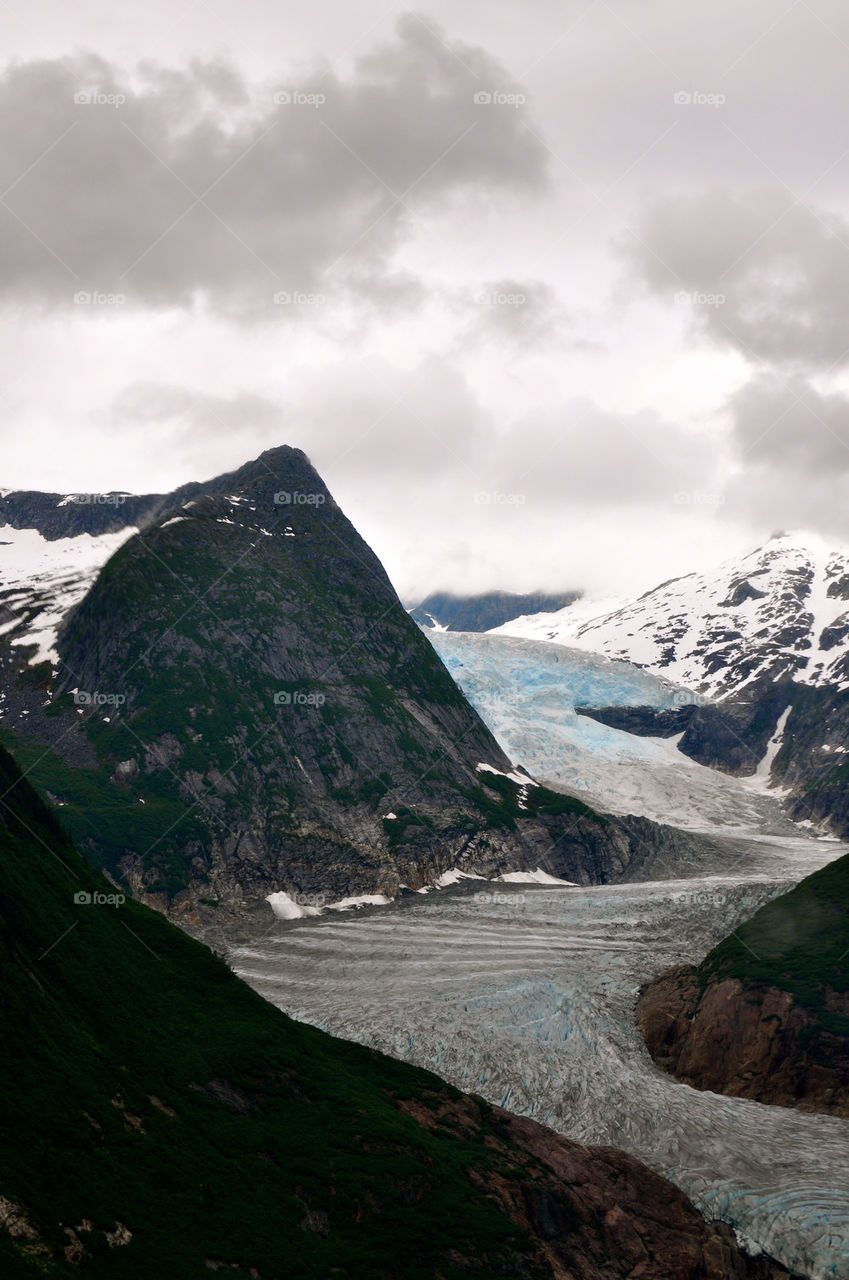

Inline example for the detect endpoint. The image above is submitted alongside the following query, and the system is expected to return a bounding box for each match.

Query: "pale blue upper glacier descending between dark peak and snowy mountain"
[425,630,795,835]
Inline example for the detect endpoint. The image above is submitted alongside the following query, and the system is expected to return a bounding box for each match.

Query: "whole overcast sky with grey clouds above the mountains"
[0,0,849,600]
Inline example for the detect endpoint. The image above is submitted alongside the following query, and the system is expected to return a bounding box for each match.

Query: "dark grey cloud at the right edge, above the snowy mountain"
[630,189,849,370]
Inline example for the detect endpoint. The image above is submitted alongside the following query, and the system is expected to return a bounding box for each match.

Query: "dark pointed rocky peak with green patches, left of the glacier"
[0,447,690,928]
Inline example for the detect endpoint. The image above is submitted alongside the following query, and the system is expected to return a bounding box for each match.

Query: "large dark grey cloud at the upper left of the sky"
[0,15,546,314]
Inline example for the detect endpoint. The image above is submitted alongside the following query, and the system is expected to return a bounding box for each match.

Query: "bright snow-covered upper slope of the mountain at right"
[498,534,849,699]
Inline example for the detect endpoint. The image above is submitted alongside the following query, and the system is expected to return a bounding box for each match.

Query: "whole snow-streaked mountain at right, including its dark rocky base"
[494,534,849,837]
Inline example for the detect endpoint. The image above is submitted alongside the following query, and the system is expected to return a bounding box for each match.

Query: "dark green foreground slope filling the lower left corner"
[0,749,786,1280]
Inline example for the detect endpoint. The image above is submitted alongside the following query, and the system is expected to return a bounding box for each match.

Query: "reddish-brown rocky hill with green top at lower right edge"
[638,855,849,1116]
